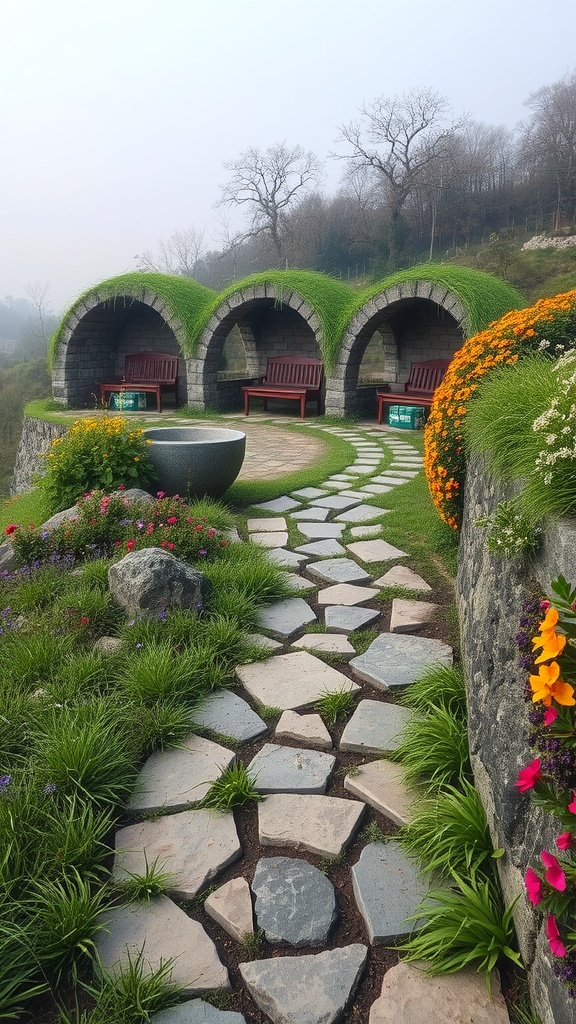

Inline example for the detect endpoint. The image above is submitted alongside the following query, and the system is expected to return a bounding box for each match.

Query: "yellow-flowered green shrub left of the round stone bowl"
[42,416,156,512]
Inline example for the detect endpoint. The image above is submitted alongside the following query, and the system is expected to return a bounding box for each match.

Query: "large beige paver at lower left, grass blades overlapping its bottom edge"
[94,896,230,995]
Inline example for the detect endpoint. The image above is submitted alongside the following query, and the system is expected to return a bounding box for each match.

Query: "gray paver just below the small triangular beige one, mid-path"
[248,743,335,793]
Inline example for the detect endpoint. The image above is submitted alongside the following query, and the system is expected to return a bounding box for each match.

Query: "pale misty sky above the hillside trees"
[0,0,576,309]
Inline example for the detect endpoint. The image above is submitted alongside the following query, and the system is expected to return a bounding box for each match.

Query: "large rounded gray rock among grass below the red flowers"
[108,548,205,615]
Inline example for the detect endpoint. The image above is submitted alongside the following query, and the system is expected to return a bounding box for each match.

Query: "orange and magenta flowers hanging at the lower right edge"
[517,577,576,998]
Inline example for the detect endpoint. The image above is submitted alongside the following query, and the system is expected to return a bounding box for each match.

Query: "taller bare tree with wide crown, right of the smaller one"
[340,89,465,266]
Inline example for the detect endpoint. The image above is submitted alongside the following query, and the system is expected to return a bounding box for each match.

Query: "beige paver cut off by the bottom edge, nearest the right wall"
[369,964,509,1024]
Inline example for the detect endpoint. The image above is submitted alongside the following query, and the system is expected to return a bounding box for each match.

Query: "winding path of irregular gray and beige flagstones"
[97,423,508,1024]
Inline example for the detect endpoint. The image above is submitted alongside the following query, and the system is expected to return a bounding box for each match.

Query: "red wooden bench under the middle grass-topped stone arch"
[242,355,324,420]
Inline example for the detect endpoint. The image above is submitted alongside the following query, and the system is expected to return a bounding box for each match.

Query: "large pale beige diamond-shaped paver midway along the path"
[236,650,360,711]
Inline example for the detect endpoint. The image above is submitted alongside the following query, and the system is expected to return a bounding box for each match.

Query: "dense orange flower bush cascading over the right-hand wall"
[424,289,576,529]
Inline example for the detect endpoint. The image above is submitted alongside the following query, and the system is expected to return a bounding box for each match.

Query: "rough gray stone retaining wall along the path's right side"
[457,460,576,1024]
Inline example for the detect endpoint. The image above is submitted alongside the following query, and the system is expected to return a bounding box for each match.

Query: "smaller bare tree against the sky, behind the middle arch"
[217,142,322,260]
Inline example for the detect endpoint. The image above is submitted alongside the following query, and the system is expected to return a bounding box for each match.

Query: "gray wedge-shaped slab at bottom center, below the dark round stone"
[240,944,367,1024]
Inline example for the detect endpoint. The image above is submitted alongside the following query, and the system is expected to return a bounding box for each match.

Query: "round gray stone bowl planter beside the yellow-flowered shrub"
[145,427,246,498]
